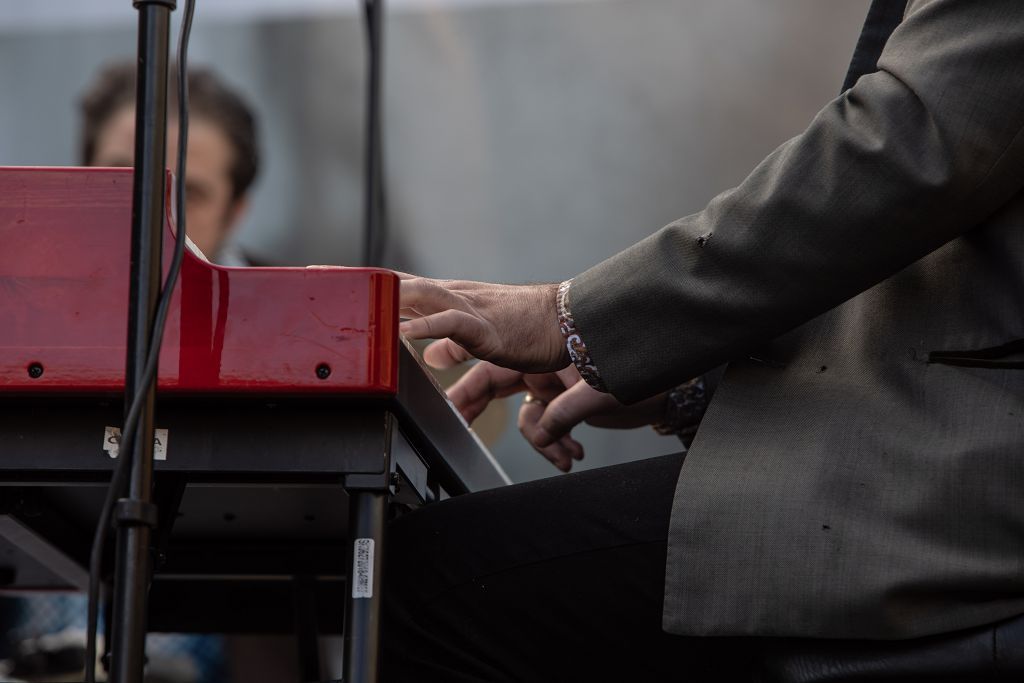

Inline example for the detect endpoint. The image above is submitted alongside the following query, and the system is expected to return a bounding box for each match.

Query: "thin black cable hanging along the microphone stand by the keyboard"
[85,0,196,683]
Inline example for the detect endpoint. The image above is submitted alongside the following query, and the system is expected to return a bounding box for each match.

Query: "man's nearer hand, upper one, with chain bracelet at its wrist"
[399,274,569,373]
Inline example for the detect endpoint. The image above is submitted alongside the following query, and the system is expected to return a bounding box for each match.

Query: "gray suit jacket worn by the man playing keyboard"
[569,0,1024,638]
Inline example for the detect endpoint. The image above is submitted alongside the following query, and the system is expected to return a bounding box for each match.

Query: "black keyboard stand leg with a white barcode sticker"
[344,490,387,683]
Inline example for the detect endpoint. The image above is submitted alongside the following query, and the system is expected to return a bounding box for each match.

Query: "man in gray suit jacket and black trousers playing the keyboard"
[386,0,1024,681]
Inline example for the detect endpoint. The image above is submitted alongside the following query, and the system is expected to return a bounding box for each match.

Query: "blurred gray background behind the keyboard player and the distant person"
[0,0,868,481]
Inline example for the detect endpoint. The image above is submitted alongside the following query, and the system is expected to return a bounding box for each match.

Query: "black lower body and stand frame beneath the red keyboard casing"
[0,347,507,683]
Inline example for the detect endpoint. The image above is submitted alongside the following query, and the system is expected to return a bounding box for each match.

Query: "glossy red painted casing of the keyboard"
[0,168,398,395]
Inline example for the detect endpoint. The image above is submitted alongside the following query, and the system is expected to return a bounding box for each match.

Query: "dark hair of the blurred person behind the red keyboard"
[80,61,259,200]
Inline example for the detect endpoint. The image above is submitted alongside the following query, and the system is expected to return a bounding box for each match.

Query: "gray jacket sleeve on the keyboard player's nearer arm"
[569,0,1024,402]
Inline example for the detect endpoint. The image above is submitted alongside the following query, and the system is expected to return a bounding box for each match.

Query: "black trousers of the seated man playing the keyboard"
[383,455,1024,683]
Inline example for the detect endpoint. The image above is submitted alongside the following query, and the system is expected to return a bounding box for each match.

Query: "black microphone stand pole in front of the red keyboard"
[112,0,177,683]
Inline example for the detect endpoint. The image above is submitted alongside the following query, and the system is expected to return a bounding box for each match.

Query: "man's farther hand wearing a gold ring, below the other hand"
[448,362,665,472]
